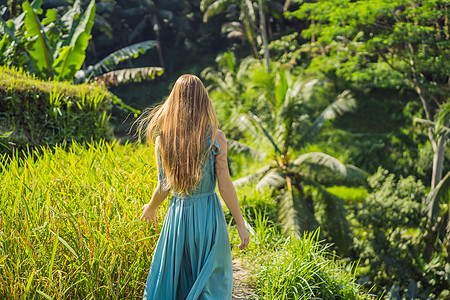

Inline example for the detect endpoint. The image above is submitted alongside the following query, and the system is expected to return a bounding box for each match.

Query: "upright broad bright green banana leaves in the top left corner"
[0,0,95,80]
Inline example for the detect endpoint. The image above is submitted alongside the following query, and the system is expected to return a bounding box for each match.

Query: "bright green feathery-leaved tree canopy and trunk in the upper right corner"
[289,0,450,187]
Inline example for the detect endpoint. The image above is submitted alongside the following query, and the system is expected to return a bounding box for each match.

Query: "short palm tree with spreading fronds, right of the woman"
[234,70,367,255]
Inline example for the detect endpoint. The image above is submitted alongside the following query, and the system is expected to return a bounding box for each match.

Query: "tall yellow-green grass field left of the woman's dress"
[0,142,162,299]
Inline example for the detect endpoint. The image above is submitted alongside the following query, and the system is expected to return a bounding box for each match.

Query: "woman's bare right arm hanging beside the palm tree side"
[215,130,250,250]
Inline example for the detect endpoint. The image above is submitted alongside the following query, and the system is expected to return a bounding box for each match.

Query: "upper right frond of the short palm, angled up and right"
[308,90,356,140]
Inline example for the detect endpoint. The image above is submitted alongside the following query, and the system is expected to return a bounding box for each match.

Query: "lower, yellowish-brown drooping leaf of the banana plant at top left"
[94,67,164,86]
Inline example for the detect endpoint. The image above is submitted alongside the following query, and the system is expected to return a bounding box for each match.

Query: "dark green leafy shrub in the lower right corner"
[355,168,450,299]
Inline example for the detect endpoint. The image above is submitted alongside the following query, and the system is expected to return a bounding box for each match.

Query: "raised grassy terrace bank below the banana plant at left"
[0,66,119,153]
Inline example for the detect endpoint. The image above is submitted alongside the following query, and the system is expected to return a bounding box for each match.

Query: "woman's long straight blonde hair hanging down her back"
[137,74,218,195]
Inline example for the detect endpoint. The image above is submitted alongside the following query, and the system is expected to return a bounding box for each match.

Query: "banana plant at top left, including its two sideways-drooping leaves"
[0,0,163,83]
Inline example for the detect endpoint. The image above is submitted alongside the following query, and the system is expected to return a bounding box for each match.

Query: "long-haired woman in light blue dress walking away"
[138,75,249,300]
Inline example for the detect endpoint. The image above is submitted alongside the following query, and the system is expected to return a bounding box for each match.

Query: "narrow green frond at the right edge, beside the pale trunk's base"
[424,172,450,228]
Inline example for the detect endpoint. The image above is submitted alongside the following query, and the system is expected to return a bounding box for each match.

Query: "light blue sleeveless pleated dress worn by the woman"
[144,138,233,300]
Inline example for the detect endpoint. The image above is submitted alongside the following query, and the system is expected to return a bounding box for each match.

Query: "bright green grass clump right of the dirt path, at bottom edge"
[232,212,374,300]
